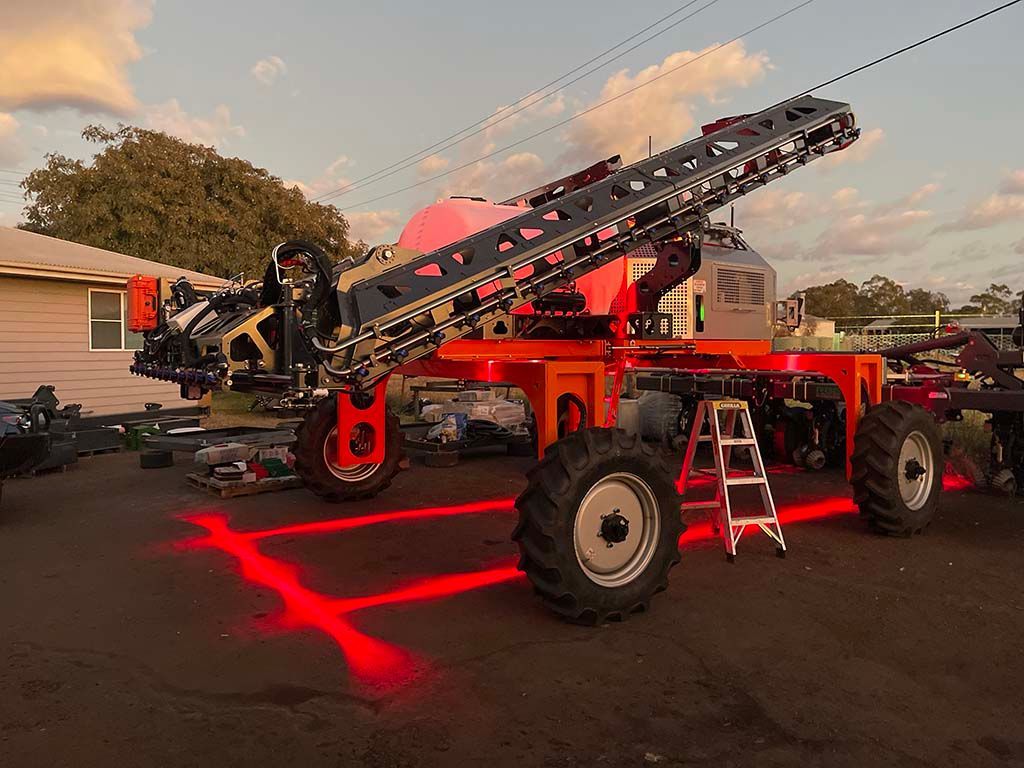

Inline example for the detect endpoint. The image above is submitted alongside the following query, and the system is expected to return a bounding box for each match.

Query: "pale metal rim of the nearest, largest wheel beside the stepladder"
[573,472,662,587]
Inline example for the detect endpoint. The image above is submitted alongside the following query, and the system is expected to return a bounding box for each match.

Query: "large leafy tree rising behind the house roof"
[20,126,361,278]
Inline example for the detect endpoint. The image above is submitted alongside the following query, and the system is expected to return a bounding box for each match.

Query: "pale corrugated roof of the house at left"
[0,226,225,287]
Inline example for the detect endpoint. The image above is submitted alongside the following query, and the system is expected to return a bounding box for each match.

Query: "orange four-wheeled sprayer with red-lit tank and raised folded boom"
[129,96,1024,622]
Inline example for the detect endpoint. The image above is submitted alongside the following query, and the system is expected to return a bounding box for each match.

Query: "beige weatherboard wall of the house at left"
[0,276,185,416]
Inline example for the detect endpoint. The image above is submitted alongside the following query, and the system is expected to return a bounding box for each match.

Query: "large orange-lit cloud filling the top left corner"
[0,0,153,116]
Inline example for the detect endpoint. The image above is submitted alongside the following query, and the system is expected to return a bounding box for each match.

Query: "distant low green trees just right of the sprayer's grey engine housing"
[804,274,949,317]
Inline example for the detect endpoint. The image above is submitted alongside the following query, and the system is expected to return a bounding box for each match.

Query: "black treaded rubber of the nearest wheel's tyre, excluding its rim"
[512,428,685,625]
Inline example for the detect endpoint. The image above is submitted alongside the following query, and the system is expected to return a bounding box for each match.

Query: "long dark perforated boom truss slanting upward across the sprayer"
[314,96,859,389]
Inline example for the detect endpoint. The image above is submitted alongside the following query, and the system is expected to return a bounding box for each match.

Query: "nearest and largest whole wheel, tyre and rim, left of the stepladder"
[512,428,685,625]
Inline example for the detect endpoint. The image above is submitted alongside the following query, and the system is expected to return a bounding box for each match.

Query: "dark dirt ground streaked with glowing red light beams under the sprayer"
[0,454,1024,768]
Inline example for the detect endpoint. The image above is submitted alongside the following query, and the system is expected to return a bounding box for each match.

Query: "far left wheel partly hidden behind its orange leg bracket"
[294,397,402,502]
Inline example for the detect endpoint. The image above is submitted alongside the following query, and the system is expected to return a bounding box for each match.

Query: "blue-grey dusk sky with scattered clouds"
[0,0,1024,303]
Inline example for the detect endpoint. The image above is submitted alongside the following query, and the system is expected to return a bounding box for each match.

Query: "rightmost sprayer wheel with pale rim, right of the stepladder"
[851,400,944,537]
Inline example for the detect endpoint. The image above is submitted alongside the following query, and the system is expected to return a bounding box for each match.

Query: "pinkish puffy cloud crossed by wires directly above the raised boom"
[564,42,769,166]
